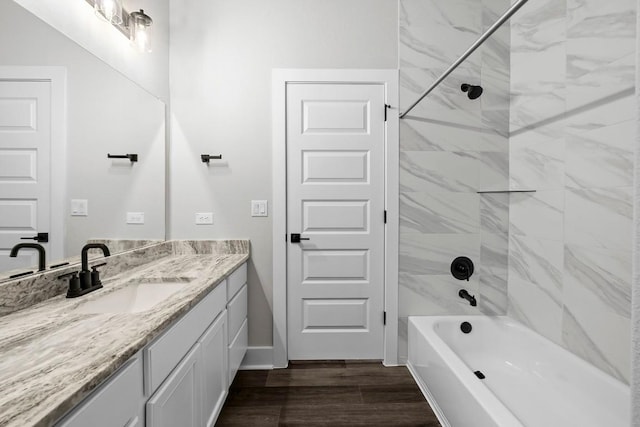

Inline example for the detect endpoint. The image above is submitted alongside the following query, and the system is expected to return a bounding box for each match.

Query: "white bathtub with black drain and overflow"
[408,316,630,427]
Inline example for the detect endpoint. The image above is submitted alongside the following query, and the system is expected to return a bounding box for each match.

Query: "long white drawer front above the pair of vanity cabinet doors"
[143,282,227,394]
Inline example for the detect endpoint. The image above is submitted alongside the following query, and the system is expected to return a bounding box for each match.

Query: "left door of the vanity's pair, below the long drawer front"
[147,344,202,427]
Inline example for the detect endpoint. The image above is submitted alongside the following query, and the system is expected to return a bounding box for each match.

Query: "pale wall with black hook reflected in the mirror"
[0,2,165,261]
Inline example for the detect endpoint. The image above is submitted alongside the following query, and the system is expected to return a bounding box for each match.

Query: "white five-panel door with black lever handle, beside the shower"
[287,82,385,360]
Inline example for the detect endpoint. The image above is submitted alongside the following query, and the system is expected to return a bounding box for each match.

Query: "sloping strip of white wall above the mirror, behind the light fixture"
[14,0,169,102]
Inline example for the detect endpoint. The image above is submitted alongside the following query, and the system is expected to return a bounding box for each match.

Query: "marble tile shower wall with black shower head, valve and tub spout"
[399,0,510,360]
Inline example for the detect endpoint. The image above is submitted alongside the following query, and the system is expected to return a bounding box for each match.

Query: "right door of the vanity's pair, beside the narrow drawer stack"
[198,311,229,426]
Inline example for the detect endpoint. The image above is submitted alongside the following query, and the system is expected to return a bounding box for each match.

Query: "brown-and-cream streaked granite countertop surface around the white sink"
[0,254,249,426]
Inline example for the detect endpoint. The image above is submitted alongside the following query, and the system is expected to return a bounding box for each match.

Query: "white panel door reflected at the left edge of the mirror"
[0,81,51,271]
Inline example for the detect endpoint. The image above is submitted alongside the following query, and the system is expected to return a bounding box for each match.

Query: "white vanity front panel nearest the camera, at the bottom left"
[57,356,144,427]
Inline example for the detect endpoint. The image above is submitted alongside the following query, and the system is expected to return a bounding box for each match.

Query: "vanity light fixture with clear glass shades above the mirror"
[85,0,153,52]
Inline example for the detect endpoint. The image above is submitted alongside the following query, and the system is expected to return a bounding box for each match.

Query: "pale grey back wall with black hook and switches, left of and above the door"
[170,0,398,346]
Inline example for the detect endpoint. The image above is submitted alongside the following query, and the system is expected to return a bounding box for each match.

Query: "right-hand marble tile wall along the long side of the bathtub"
[508,0,636,382]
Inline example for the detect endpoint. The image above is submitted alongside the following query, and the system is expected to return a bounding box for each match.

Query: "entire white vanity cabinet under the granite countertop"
[53,263,247,427]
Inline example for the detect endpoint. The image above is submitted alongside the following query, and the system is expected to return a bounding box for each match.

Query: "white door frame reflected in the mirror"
[0,66,67,260]
